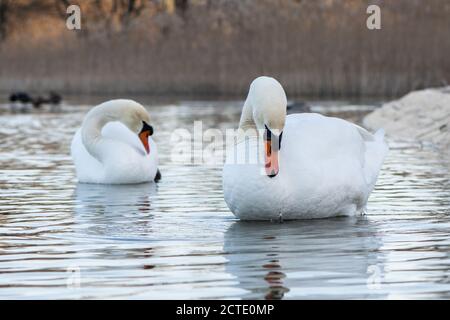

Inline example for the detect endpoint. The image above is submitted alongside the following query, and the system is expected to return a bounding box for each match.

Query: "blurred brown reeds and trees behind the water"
[0,0,450,98]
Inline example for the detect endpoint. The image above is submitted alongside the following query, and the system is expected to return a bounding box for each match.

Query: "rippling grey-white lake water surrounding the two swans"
[0,103,450,299]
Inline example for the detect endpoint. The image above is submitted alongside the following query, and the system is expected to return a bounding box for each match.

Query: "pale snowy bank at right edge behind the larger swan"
[364,86,450,154]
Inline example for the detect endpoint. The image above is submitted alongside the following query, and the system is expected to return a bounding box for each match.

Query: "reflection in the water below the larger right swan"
[224,217,384,299]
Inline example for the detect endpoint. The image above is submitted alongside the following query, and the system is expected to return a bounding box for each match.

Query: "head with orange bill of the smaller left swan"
[118,100,153,154]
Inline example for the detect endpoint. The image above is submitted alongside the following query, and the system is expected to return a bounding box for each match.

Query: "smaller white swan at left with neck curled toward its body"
[71,100,160,184]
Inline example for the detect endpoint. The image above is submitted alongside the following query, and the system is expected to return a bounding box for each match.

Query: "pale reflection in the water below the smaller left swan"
[75,183,157,238]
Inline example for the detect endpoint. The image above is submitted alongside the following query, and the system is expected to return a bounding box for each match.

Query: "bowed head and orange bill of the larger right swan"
[249,77,287,178]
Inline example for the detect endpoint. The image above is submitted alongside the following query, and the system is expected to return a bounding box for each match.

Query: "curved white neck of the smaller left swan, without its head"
[81,107,120,162]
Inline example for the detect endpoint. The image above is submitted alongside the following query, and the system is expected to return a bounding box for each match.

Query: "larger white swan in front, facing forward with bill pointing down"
[223,77,388,220]
